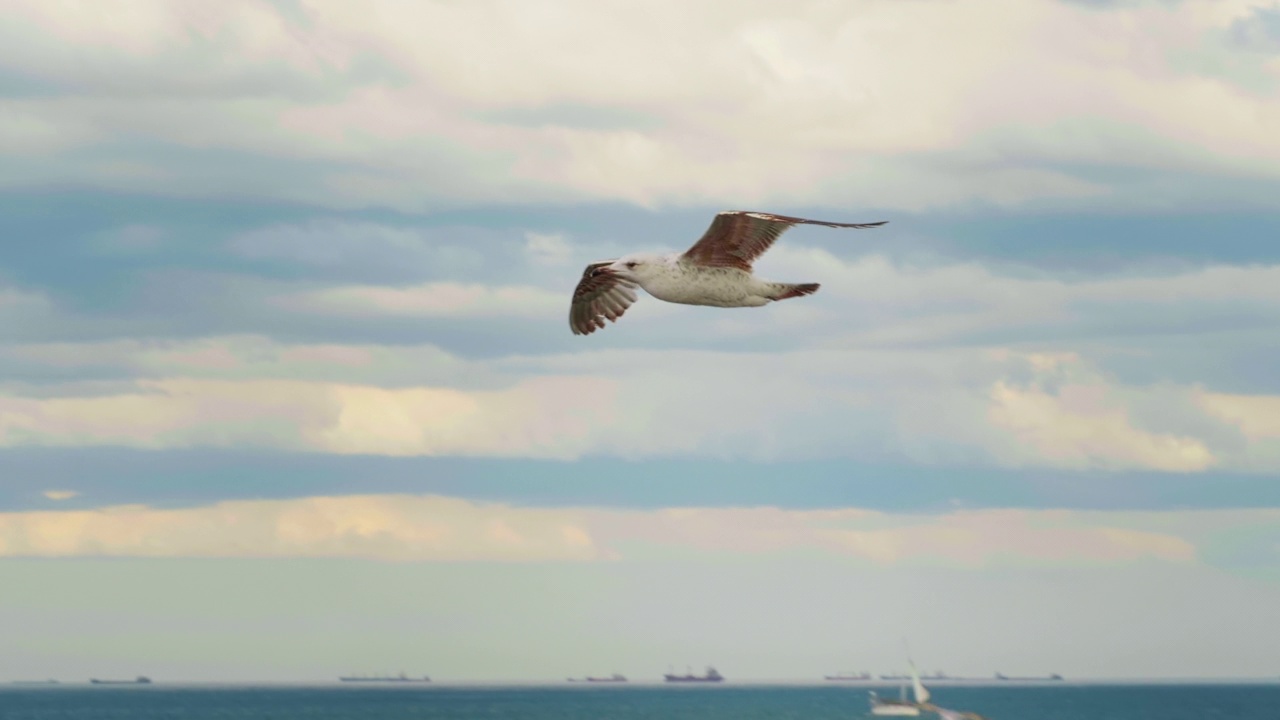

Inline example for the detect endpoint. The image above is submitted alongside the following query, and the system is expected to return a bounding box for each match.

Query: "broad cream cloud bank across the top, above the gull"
[0,0,1280,211]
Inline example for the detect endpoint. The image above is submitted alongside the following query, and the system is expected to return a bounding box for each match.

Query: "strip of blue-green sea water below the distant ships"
[0,683,1280,720]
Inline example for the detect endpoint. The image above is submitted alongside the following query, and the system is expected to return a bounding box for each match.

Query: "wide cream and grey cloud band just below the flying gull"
[0,337,1280,473]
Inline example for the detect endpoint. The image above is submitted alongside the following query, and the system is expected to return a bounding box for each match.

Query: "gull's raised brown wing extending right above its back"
[684,210,887,273]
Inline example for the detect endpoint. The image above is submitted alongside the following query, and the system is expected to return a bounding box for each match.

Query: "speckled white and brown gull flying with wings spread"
[568,210,887,334]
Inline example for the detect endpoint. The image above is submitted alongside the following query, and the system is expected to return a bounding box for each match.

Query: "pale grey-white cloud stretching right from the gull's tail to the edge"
[756,242,1280,347]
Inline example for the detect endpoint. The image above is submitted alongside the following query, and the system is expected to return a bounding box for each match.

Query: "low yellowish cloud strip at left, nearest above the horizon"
[0,496,600,561]
